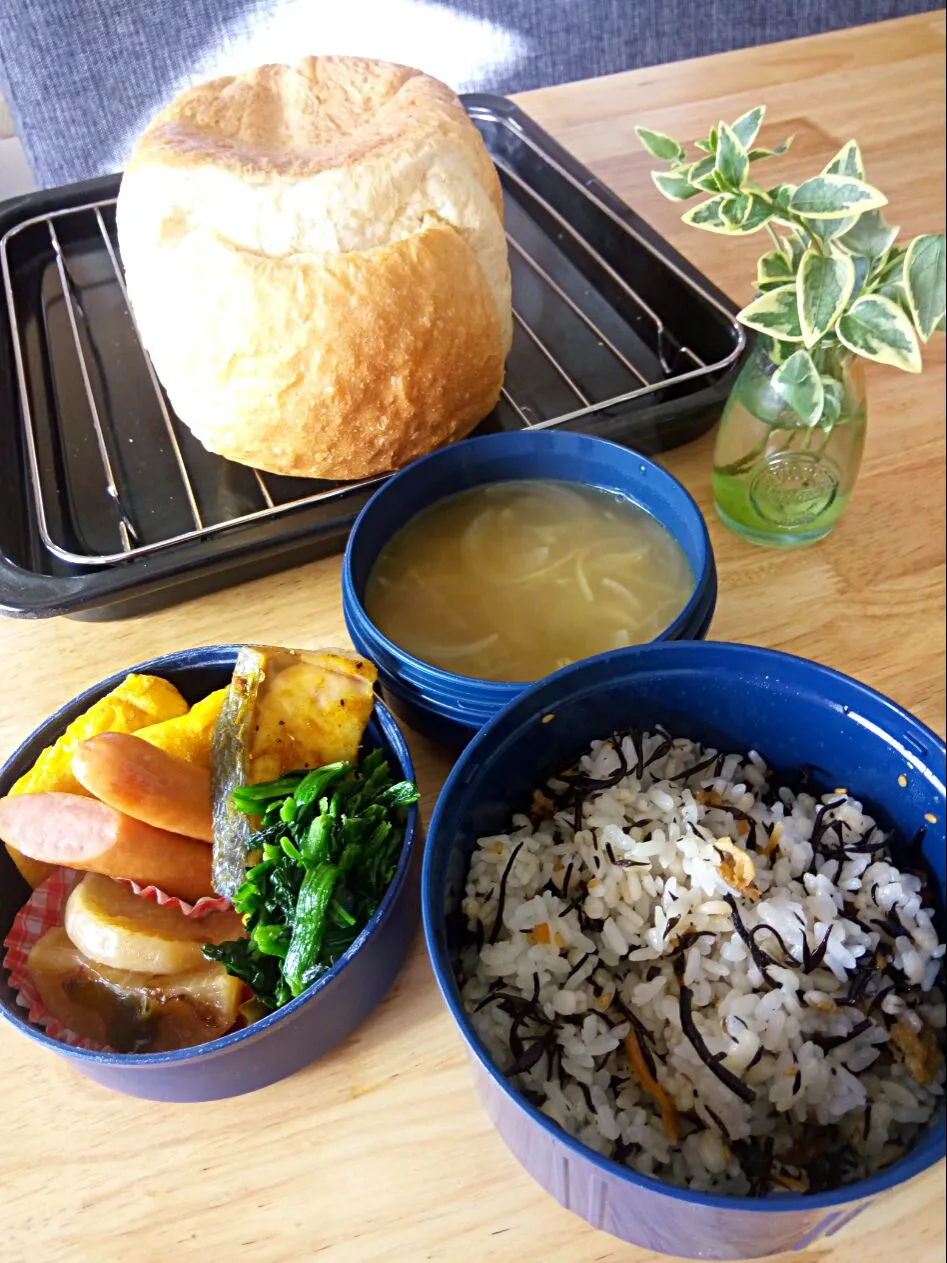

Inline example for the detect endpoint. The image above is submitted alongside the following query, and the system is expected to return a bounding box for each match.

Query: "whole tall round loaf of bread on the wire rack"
[117,57,513,479]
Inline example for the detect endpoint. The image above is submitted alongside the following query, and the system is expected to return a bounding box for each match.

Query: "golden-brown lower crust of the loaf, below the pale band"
[138,227,503,479]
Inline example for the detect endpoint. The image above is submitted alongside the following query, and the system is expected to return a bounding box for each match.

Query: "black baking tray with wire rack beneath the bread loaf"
[0,95,745,619]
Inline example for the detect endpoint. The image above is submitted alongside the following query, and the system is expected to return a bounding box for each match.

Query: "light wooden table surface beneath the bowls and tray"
[0,11,944,1263]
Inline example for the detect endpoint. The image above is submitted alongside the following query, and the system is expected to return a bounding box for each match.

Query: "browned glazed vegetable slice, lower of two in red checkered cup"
[27,928,244,1052]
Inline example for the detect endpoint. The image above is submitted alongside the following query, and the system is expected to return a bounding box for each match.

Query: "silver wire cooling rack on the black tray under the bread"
[0,97,744,608]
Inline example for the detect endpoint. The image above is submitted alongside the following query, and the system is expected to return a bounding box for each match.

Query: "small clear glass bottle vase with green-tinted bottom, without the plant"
[713,340,866,548]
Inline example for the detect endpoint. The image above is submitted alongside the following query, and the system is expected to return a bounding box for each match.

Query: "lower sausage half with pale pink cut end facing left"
[0,793,213,903]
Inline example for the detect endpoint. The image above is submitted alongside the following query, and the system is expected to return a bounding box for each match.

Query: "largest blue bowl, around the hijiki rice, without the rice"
[422,643,944,1259]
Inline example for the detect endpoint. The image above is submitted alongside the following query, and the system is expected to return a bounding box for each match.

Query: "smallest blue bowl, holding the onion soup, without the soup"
[342,429,717,749]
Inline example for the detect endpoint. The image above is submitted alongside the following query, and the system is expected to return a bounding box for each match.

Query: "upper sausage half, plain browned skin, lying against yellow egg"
[72,733,213,842]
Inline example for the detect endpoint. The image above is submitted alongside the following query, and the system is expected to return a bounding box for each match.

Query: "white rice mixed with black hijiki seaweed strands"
[458,730,944,1196]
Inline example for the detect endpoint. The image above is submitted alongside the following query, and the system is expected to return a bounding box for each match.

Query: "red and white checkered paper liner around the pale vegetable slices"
[3,868,230,1052]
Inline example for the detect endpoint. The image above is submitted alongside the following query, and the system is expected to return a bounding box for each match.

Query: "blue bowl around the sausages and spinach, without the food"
[0,645,419,1101]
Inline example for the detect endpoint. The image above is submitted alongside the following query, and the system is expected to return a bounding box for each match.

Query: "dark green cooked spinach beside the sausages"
[203,750,419,1009]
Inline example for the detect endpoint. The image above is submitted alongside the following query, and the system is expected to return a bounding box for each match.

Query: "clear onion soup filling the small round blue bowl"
[365,479,694,682]
